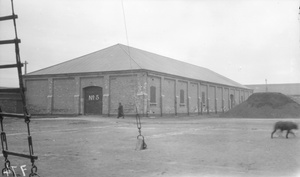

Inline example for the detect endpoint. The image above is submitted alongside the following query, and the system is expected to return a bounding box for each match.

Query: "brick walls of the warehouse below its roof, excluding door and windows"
[26,72,250,116]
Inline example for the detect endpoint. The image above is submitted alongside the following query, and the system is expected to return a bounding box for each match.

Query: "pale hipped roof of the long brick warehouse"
[27,44,247,88]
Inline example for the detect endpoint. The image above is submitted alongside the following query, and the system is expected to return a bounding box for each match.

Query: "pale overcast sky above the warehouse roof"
[0,0,300,86]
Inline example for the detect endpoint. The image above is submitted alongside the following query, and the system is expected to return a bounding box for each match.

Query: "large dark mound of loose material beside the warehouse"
[220,92,300,118]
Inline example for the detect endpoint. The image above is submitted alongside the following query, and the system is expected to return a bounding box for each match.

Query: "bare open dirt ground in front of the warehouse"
[0,116,300,177]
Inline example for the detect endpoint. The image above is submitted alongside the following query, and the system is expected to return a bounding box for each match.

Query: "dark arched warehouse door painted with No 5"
[83,86,103,115]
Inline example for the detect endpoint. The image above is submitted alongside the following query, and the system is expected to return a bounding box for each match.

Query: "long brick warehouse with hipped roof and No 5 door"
[24,44,252,116]
